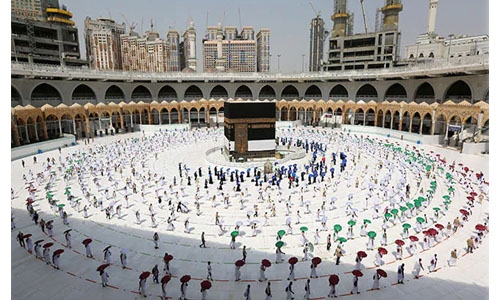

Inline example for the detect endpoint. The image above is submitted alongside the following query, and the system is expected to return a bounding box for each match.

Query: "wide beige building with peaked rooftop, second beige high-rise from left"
[120,25,169,73]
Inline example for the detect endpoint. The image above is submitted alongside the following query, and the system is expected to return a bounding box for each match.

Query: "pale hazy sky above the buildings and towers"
[36,0,489,72]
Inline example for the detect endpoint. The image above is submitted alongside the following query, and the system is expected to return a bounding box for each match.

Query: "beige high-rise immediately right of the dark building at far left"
[85,17,125,70]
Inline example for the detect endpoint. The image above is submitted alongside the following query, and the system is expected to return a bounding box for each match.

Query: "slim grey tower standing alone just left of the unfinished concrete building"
[309,15,328,72]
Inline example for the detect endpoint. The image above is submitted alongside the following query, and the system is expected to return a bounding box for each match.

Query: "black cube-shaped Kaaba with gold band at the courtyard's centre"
[224,101,276,161]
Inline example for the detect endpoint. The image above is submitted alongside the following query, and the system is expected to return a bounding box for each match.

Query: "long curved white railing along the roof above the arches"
[11,54,489,82]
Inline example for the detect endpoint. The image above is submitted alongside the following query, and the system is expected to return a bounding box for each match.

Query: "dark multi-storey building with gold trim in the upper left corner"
[11,0,87,66]
